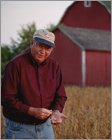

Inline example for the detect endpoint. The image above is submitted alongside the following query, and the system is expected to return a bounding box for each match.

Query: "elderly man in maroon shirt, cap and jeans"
[1,29,67,139]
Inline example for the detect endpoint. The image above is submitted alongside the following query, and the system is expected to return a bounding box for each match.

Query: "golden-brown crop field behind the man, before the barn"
[1,86,111,139]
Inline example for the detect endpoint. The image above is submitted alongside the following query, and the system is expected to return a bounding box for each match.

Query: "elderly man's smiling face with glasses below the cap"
[30,39,53,64]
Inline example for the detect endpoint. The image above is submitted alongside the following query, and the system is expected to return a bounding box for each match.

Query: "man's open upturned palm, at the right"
[50,111,67,124]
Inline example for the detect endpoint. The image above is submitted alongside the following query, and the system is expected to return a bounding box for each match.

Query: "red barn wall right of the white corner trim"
[86,51,111,86]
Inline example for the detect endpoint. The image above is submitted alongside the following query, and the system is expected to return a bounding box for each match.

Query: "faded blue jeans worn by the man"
[5,118,55,139]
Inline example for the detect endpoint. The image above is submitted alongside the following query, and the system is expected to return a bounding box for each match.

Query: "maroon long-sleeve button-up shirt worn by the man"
[1,49,67,123]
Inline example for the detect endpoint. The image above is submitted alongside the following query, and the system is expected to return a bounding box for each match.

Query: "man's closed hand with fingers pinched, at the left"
[28,107,52,120]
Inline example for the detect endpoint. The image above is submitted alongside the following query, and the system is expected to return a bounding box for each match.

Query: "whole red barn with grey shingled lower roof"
[51,1,111,86]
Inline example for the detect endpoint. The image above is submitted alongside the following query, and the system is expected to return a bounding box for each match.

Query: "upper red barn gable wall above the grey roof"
[60,1,111,31]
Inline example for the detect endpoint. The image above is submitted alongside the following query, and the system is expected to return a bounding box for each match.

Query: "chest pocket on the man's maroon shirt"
[46,79,56,94]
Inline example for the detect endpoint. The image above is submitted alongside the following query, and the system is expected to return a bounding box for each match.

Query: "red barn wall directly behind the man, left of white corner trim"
[51,29,82,86]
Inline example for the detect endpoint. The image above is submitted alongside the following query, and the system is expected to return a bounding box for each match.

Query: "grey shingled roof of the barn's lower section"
[55,26,111,51]
